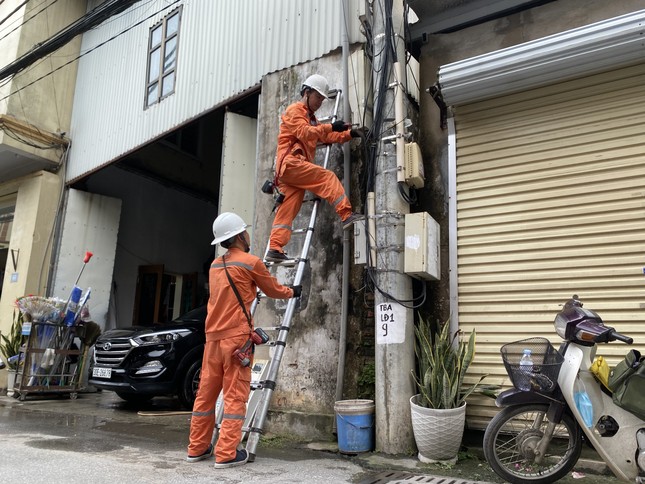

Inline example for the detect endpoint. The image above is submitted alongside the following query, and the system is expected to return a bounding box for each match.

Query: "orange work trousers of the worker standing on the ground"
[188,335,253,462]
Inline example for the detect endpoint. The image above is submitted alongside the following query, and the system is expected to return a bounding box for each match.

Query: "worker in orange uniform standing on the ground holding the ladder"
[186,212,302,468]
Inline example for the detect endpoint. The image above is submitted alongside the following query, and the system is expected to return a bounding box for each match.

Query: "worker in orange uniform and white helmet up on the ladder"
[265,74,362,262]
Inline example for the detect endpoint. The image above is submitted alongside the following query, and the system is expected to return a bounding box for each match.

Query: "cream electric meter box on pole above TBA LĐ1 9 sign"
[403,212,441,281]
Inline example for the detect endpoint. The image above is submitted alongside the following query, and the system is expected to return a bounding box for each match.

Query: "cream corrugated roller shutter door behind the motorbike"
[455,64,645,426]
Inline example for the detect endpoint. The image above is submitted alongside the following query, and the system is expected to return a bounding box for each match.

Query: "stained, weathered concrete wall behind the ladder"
[251,53,362,438]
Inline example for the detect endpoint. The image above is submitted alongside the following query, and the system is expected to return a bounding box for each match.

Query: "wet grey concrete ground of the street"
[0,392,618,484]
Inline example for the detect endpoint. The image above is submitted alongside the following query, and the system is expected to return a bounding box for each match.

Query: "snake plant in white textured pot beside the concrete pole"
[410,318,490,464]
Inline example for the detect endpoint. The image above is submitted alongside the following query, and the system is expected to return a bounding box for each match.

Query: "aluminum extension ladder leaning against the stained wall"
[212,90,342,462]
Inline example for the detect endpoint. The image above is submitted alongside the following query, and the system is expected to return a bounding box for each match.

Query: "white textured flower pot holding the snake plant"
[410,395,466,464]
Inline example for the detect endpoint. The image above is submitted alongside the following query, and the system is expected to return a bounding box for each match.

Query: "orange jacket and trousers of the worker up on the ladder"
[269,101,352,252]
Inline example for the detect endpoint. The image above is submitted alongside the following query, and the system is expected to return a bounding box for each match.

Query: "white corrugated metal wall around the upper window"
[67,0,364,181]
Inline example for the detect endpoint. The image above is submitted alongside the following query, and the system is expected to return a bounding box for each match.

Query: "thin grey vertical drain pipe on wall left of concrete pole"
[334,0,353,412]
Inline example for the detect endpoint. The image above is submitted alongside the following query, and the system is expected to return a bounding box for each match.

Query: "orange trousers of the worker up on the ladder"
[269,156,352,251]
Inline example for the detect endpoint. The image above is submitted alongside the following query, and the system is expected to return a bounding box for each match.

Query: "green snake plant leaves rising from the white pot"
[413,318,494,408]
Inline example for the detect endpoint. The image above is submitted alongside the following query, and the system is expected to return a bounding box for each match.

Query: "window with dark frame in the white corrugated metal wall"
[145,7,181,107]
